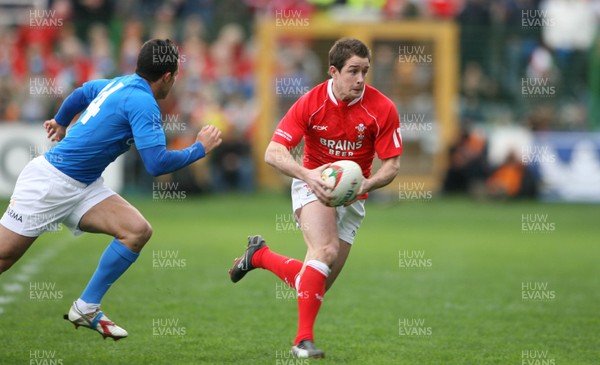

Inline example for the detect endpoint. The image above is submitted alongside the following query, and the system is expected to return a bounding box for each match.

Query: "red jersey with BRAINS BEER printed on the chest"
[272,79,402,178]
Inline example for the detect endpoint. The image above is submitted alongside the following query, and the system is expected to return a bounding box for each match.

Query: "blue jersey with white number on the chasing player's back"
[45,74,166,184]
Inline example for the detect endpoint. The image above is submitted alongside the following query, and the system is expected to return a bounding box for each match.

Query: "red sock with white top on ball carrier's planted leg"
[294,260,331,345]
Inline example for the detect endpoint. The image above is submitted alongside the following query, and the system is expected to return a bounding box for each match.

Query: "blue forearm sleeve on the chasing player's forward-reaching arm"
[139,142,206,176]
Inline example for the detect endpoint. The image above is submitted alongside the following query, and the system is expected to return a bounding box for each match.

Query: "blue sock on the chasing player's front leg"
[77,238,140,313]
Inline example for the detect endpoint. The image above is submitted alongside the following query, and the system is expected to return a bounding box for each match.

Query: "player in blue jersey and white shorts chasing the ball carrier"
[0,39,221,340]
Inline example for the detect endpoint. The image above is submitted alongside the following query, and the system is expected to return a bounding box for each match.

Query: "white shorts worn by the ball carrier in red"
[292,179,366,244]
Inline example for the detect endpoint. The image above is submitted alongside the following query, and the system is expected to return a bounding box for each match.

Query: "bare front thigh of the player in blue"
[79,194,152,246]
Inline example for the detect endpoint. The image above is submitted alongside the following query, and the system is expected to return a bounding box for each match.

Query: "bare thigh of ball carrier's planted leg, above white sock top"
[296,201,339,265]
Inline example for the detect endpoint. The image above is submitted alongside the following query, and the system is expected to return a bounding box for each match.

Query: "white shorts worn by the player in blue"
[0,156,116,237]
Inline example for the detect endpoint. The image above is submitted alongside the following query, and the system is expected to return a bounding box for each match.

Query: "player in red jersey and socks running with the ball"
[229,38,402,358]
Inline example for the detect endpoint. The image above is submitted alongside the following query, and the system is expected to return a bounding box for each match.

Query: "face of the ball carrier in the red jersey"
[329,55,371,101]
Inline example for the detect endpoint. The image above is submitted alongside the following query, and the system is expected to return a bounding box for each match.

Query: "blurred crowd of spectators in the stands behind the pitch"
[0,0,600,198]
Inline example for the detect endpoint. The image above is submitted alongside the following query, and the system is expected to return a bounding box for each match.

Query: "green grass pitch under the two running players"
[0,194,600,365]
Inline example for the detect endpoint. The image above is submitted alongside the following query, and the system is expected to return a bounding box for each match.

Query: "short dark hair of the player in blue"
[135,39,179,82]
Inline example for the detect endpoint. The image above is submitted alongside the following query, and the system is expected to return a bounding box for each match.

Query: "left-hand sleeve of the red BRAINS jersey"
[271,94,308,149]
